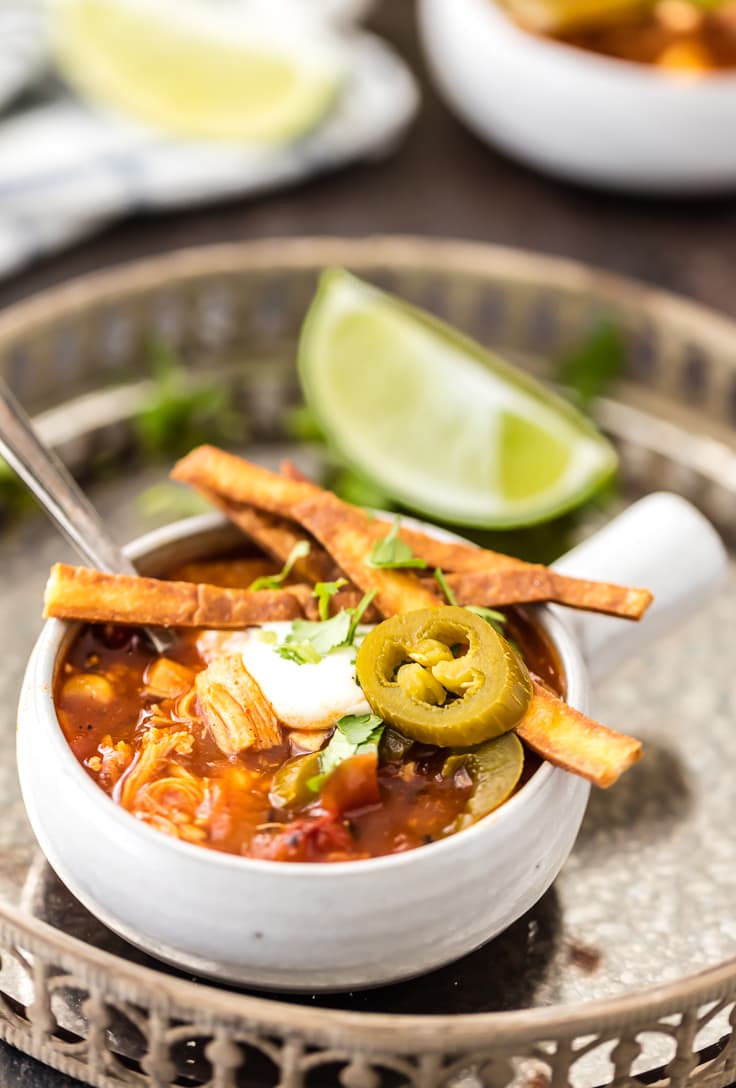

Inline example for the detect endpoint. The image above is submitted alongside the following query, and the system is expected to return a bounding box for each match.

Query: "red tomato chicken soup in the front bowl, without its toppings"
[56,558,563,862]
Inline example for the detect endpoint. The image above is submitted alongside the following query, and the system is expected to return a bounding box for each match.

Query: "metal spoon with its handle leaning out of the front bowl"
[0,378,173,654]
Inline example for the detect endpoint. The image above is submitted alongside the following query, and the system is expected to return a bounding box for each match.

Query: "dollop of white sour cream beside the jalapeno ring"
[198,622,370,732]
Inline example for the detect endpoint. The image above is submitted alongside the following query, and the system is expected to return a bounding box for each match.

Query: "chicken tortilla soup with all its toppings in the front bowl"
[45,447,652,862]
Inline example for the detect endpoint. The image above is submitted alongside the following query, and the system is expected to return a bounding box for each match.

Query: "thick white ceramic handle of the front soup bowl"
[554,492,728,683]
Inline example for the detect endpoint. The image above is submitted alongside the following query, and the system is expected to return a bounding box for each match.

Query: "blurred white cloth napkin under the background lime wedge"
[0,33,418,276]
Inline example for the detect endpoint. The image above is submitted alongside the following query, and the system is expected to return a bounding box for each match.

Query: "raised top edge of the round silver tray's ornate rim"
[0,235,736,1048]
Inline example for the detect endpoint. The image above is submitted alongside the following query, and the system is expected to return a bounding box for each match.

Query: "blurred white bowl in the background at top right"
[419,0,736,194]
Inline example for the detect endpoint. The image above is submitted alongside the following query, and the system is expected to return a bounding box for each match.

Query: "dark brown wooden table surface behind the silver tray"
[0,0,736,1088]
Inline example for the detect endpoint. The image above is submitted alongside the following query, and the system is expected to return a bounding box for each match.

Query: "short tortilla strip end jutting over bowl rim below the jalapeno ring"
[516,679,642,789]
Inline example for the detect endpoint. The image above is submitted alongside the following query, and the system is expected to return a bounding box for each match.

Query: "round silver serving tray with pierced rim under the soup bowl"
[0,239,736,1088]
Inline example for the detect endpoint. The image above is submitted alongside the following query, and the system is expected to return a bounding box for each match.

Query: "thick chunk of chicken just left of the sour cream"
[196,654,281,755]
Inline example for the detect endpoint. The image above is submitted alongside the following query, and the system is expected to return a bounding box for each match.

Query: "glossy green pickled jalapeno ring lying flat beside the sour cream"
[356,605,531,747]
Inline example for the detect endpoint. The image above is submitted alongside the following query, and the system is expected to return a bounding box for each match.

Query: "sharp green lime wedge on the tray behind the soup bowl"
[298,269,616,528]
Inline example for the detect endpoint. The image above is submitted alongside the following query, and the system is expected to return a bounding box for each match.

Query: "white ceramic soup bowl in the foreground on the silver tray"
[17,496,722,990]
